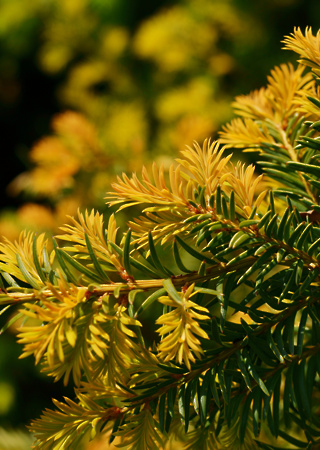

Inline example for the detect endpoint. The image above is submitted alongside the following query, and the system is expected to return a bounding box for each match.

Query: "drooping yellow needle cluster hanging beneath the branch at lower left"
[18,284,140,385]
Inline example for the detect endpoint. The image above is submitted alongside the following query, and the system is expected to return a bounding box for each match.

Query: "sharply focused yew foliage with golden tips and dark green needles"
[0,29,320,450]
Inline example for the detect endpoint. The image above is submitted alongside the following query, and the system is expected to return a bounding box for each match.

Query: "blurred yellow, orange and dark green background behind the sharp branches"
[0,0,320,444]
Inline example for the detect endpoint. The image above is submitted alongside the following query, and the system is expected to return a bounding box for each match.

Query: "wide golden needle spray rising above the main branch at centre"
[102,140,266,248]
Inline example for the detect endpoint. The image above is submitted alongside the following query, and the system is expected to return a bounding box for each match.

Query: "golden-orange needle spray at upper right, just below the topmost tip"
[220,53,318,204]
